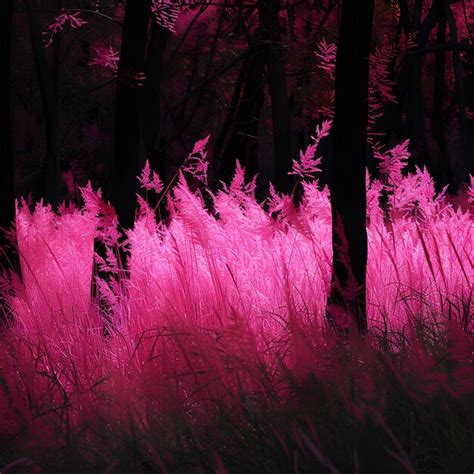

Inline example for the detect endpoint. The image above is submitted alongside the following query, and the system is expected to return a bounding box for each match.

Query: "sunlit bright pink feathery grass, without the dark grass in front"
[0,141,473,460]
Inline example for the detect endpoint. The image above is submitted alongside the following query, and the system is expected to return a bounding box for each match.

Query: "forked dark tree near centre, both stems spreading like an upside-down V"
[217,0,292,193]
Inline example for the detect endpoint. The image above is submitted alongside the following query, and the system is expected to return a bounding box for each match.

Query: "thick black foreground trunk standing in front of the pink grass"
[327,0,374,332]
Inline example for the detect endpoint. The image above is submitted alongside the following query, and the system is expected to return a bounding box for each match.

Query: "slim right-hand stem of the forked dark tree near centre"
[258,0,293,193]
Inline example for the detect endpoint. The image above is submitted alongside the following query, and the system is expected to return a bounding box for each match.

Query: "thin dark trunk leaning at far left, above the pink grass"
[24,0,60,204]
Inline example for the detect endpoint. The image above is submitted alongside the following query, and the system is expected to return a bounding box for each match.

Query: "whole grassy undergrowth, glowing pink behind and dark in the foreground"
[0,135,474,474]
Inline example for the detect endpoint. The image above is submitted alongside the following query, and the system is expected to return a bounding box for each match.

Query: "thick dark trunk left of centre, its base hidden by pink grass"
[111,0,150,228]
